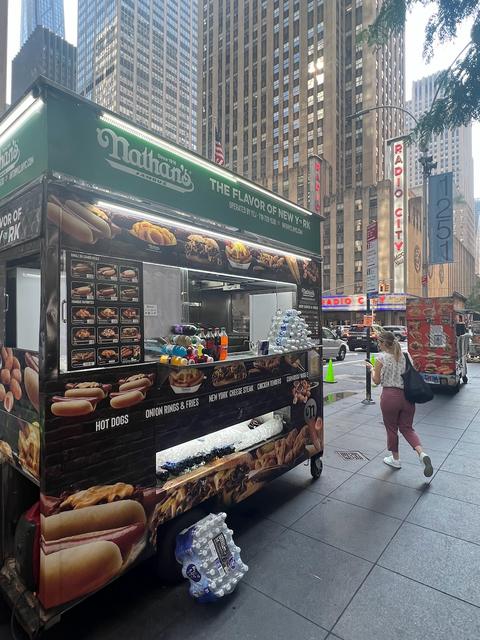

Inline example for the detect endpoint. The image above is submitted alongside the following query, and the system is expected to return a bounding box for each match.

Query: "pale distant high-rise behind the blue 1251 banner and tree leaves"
[407,73,474,212]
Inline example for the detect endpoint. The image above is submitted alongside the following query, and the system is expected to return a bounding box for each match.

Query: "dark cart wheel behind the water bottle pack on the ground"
[155,507,208,585]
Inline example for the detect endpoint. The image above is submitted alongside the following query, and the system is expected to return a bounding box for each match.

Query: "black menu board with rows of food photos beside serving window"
[66,252,144,370]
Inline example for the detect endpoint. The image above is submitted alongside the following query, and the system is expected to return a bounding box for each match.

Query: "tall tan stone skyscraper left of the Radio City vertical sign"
[198,0,404,295]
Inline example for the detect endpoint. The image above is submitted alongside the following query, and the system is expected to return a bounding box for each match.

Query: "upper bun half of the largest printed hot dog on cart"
[42,500,147,542]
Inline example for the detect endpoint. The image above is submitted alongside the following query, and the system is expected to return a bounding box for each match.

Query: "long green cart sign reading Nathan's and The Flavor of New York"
[47,90,320,253]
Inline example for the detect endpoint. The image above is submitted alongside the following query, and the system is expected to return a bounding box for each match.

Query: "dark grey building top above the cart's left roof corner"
[12,27,77,102]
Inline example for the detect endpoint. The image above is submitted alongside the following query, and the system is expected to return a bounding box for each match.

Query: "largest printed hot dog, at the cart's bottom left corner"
[39,482,147,609]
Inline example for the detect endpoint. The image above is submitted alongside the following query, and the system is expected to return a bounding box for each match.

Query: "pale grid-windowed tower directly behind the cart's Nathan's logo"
[77,0,198,149]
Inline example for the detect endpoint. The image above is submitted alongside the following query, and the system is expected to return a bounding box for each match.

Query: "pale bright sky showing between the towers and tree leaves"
[4,0,480,198]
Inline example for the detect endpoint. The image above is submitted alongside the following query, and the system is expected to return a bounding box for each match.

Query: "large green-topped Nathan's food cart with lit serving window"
[0,81,323,636]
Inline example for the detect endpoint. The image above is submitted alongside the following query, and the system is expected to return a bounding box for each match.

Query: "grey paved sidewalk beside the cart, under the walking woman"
[8,365,480,640]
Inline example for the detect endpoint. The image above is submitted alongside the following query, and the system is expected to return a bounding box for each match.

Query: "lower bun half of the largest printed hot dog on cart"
[39,544,122,609]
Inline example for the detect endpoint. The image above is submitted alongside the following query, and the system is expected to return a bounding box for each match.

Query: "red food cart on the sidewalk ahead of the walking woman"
[407,297,469,393]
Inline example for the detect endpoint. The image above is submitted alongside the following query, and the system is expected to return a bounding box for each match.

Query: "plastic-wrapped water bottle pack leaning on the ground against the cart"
[175,513,248,602]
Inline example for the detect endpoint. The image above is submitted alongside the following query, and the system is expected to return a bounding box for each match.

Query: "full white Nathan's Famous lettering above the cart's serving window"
[97,129,195,193]
